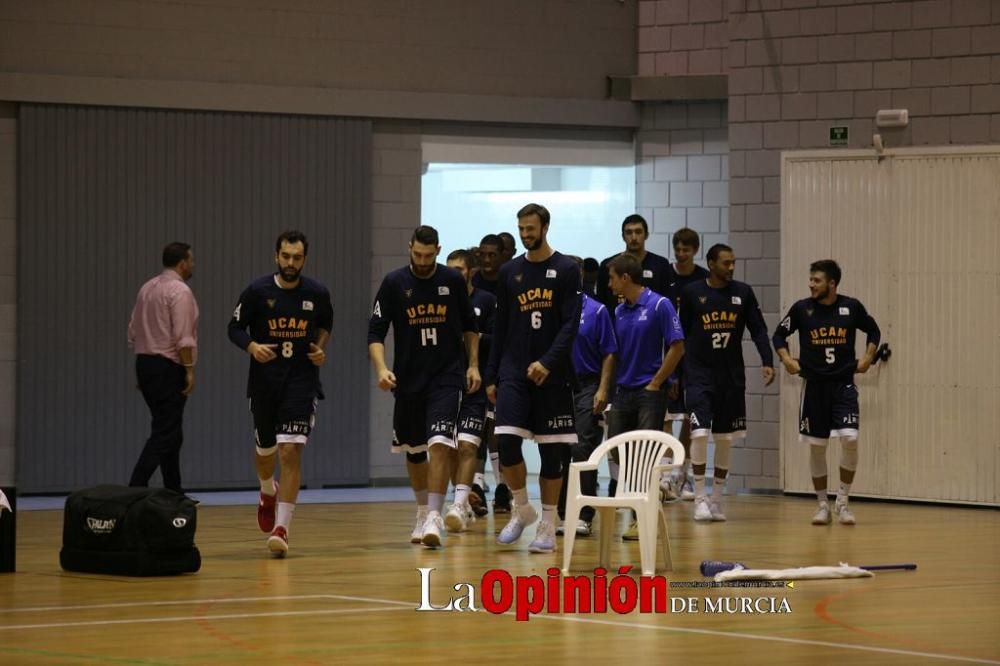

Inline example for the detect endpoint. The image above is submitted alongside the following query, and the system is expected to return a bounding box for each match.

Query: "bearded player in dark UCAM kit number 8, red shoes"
[229,231,333,557]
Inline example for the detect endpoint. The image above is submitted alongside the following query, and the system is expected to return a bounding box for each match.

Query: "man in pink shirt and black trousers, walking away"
[128,243,198,492]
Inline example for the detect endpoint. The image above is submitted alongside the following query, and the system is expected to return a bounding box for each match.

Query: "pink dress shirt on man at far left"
[128,268,198,363]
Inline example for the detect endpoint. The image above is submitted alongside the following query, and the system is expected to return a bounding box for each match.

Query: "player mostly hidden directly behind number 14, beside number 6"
[444,250,497,532]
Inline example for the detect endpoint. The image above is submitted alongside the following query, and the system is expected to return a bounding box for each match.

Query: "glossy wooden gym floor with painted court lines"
[0,496,1000,666]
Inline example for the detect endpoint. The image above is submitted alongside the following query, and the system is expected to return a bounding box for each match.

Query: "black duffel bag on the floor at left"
[59,485,201,576]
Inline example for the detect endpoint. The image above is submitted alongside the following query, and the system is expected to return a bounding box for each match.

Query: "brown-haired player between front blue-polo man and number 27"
[663,227,708,501]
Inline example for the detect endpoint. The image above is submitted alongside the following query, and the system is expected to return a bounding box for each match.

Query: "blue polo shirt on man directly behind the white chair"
[615,287,684,388]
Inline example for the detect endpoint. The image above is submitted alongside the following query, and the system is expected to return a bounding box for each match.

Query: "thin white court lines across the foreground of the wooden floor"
[0,594,1000,666]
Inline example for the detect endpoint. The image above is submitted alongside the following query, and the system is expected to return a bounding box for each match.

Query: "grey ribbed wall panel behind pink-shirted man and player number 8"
[17,105,372,492]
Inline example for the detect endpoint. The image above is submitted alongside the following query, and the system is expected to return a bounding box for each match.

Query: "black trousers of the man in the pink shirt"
[128,354,187,492]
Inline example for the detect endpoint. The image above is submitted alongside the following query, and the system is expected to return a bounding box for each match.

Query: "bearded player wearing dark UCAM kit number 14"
[368,226,480,548]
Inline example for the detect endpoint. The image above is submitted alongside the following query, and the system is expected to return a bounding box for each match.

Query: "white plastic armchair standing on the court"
[563,430,684,576]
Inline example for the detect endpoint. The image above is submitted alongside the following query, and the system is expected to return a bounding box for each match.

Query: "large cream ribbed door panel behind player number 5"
[781,147,1000,503]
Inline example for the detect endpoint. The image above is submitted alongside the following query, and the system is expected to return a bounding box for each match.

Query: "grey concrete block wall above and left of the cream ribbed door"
[638,0,1000,489]
